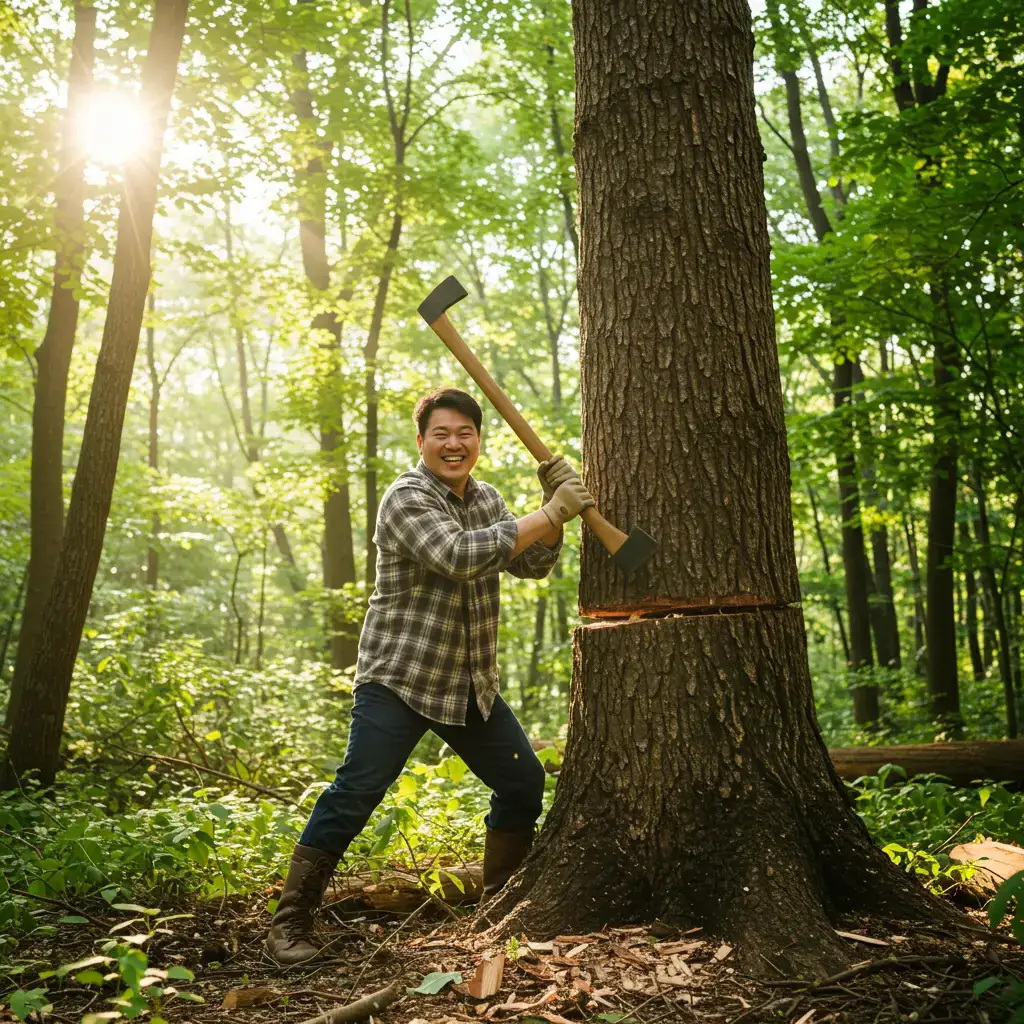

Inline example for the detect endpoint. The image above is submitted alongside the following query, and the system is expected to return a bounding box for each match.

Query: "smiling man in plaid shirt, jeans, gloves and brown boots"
[266,388,594,965]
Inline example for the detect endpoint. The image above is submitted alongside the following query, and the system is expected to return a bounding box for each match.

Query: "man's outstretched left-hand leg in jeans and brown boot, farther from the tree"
[266,683,427,965]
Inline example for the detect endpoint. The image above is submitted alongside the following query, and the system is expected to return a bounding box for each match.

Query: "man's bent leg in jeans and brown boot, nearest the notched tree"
[432,690,545,898]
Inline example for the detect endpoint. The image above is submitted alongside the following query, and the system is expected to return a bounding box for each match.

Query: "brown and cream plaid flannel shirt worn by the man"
[355,462,561,725]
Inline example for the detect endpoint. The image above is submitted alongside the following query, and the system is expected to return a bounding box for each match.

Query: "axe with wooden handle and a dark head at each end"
[418,278,657,573]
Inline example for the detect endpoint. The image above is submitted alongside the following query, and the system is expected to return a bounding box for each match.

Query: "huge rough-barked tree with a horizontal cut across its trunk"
[480,0,954,974]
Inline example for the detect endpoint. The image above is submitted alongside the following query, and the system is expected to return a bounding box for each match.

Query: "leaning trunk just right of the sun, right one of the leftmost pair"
[0,0,188,788]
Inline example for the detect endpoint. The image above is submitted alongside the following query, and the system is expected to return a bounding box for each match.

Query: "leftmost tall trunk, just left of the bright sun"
[7,3,96,726]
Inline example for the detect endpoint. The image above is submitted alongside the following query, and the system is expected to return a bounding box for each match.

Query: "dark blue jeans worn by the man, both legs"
[299,683,545,857]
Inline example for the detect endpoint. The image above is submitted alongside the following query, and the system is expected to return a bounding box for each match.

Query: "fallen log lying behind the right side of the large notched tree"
[828,739,1024,785]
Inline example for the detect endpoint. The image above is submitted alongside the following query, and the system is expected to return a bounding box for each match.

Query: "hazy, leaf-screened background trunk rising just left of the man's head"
[292,50,358,669]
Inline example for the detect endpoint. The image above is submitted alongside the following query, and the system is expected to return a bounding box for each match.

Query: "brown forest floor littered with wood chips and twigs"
[9,893,1024,1024]
